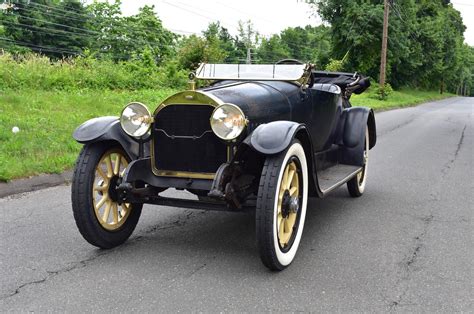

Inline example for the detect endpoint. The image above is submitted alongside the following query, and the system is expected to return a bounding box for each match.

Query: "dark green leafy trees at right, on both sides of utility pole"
[308,0,473,92]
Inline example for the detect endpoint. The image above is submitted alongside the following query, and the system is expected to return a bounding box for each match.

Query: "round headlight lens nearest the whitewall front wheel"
[211,104,246,141]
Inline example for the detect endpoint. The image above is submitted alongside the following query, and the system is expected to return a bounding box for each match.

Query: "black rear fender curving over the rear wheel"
[340,107,377,166]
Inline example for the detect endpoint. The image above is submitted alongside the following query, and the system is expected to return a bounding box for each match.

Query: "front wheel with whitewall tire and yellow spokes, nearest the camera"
[256,140,308,271]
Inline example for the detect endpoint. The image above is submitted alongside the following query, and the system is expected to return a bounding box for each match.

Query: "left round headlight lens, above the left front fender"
[120,102,153,137]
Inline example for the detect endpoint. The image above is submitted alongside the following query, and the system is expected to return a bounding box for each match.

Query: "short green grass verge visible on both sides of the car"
[0,89,452,181]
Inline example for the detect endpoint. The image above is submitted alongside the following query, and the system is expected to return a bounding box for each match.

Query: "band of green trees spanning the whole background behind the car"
[0,0,474,93]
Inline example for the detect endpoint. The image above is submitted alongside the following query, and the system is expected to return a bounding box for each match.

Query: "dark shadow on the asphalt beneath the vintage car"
[99,189,356,273]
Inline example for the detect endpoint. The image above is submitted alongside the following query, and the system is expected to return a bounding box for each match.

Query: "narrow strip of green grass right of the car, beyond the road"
[351,89,455,111]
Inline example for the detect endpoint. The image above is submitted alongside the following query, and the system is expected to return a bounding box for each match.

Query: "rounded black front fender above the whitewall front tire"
[245,121,304,155]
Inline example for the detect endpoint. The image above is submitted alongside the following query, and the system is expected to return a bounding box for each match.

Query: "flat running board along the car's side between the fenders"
[317,164,362,195]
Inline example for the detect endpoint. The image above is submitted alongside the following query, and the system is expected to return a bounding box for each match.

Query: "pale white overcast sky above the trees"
[115,0,474,46]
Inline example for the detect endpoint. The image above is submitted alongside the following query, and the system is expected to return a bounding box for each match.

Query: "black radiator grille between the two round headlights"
[153,105,227,173]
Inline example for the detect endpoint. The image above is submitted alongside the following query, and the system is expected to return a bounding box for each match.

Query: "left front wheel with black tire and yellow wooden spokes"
[71,142,143,249]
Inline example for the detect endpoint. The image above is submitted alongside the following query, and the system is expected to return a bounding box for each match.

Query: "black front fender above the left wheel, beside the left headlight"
[72,117,142,160]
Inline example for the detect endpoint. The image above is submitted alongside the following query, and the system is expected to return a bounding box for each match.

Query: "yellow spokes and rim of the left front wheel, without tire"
[92,149,131,231]
